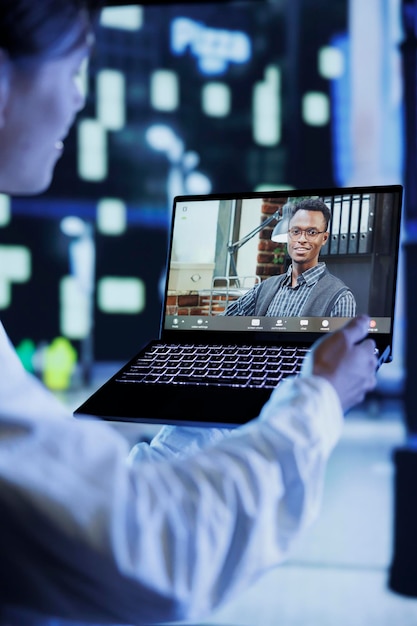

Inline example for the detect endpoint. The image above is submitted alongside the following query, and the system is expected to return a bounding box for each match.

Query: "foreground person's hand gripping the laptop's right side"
[301,315,377,412]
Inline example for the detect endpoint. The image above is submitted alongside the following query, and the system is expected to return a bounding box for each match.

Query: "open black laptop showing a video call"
[75,185,402,426]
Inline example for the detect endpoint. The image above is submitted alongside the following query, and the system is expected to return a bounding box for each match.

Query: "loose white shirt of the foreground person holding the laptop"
[0,325,342,624]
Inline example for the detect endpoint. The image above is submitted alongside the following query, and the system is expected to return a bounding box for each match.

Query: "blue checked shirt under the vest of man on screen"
[224,263,356,317]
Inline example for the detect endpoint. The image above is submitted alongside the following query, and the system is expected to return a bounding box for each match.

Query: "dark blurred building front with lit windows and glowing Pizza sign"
[0,0,403,385]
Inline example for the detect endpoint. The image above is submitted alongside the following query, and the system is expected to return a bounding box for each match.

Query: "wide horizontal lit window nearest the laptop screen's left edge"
[97,276,146,315]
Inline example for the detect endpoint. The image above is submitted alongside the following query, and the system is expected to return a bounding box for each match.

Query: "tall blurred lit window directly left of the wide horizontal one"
[60,276,92,339]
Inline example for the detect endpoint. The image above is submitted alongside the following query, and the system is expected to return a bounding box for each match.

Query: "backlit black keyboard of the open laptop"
[116,344,309,389]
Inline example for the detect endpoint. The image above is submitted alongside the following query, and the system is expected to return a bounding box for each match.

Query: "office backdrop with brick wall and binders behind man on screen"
[166,193,398,332]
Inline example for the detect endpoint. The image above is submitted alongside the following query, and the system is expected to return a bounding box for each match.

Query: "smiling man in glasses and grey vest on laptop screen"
[223,198,356,317]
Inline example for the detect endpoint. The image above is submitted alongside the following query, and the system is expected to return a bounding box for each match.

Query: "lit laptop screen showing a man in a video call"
[163,185,402,338]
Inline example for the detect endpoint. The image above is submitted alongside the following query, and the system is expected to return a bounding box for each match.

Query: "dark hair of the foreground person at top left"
[0,0,102,61]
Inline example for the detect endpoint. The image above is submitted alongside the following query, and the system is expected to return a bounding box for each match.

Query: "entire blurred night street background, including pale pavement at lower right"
[0,0,417,626]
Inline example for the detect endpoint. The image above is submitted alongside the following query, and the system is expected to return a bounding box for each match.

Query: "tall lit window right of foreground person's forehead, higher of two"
[97,70,126,130]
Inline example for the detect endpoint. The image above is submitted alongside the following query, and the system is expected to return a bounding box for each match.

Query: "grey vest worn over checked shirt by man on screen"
[255,269,350,317]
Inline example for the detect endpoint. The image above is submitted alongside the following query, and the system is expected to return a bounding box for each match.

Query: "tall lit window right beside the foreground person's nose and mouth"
[78,119,108,182]
